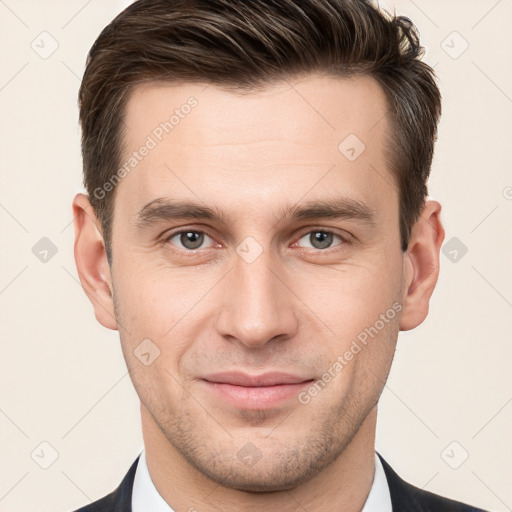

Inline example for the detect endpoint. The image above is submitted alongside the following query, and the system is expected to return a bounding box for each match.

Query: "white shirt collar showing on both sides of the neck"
[132,450,393,512]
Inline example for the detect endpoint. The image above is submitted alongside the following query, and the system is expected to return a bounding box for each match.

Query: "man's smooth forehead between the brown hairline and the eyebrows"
[115,76,396,224]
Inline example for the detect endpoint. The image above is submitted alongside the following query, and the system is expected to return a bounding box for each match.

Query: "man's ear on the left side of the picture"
[73,194,117,330]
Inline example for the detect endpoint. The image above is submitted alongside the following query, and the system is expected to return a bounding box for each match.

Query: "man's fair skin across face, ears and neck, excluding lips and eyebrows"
[73,75,444,512]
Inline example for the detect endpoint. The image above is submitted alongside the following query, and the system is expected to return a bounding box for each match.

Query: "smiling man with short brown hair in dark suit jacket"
[73,0,486,512]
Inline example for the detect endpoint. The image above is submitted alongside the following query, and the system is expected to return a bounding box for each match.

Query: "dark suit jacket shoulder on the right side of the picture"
[378,454,485,512]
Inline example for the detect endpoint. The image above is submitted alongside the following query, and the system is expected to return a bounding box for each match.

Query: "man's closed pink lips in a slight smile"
[201,372,314,409]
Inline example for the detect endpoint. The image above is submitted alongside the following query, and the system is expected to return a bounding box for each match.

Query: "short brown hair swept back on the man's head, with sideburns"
[79,0,441,262]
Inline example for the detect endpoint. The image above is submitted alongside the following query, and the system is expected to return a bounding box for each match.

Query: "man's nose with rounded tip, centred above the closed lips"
[213,247,298,348]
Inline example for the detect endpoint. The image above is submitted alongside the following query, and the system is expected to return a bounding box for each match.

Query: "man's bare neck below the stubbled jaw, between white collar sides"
[141,404,377,512]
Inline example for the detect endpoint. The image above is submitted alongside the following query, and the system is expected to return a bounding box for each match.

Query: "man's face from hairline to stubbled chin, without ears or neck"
[107,76,404,491]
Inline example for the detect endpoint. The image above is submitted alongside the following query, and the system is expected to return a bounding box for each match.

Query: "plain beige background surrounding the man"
[0,0,512,512]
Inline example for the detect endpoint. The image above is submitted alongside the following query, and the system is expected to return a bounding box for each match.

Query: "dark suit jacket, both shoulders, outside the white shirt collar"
[70,455,484,512]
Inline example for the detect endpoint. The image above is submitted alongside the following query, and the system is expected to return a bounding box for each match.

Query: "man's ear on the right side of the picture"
[400,201,444,331]
